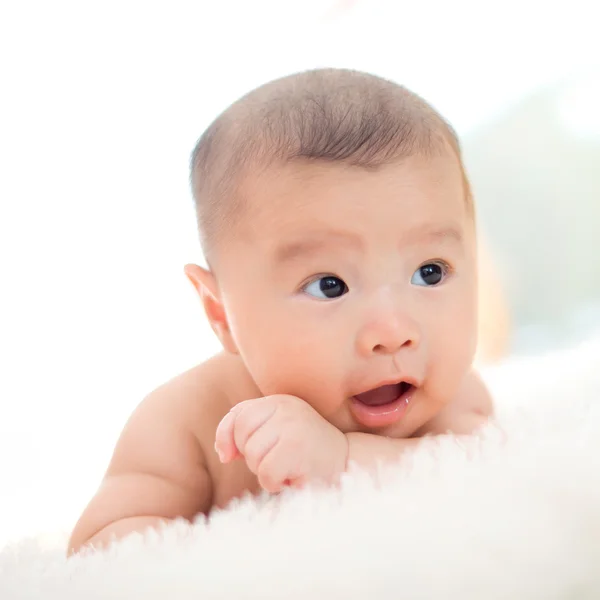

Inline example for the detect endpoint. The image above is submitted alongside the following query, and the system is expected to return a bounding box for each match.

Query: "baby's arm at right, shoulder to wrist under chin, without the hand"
[346,372,493,469]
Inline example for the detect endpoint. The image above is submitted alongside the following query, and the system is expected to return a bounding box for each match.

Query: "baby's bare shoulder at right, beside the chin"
[418,370,494,435]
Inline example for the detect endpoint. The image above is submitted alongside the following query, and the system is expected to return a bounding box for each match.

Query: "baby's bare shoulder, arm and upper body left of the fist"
[69,354,260,552]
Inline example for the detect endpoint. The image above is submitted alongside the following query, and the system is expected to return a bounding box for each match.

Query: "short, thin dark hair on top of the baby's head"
[190,69,466,255]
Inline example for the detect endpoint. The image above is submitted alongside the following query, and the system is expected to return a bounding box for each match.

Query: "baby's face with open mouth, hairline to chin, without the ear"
[216,156,477,437]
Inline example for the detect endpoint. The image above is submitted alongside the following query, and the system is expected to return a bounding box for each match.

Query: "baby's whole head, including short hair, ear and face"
[187,70,477,436]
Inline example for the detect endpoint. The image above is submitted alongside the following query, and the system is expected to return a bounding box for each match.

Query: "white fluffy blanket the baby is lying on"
[0,340,600,600]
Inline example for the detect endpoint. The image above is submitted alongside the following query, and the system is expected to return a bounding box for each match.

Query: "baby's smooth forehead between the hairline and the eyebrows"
[230,159,467,255]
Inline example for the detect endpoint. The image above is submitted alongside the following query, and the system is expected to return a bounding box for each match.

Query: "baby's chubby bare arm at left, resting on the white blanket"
[69,385,212,553]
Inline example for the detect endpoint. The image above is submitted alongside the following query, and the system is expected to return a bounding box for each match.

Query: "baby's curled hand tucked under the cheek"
[215,395,348,493]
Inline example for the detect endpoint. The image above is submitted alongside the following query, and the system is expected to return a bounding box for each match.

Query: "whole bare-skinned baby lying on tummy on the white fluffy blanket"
[69,69,492,552]
